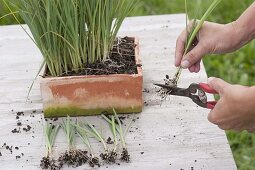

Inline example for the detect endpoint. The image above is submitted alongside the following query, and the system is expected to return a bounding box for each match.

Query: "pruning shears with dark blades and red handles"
[154,83,218,109]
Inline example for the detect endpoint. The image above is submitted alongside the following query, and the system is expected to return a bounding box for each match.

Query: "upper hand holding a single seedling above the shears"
[175,22,241,73]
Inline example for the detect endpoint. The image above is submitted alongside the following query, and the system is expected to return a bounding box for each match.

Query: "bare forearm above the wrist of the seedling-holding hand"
[233,2,255,46]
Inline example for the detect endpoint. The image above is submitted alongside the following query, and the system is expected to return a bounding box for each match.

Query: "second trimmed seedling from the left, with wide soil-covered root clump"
[58,116,89,167]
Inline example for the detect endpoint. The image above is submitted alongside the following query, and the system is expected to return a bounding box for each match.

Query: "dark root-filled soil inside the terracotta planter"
[45,37,138,77]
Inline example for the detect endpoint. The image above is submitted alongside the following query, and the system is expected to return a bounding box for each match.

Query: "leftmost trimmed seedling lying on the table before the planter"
[40,123,60,170]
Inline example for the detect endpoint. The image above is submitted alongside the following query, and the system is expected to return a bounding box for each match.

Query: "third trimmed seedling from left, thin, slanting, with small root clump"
[74,124,100,167]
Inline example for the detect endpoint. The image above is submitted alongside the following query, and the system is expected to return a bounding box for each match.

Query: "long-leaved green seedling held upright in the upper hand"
[171,0,222,86]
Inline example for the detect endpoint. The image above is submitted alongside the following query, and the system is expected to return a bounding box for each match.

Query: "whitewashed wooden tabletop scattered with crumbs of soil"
[0,14,236,170]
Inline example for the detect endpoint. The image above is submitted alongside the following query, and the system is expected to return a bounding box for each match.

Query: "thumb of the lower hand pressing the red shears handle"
[208,77,229,95]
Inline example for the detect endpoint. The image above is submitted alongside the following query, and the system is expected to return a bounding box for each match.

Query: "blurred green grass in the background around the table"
[0,0,255,170]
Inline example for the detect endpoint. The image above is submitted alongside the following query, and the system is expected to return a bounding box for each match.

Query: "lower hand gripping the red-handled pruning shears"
[208,78,255,132]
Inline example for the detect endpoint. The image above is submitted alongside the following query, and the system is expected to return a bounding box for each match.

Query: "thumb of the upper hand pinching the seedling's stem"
[181,43,207,69]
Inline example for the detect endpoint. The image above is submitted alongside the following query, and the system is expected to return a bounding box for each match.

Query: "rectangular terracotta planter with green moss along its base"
[40,38,143,117]
